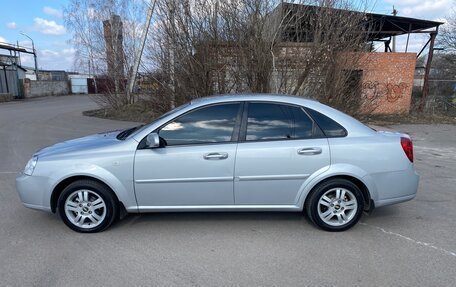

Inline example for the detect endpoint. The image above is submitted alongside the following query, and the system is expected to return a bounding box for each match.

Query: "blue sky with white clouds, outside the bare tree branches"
[0,0,456,70]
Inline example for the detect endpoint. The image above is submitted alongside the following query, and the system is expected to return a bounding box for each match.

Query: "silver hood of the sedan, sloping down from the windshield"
[35,130,120,157]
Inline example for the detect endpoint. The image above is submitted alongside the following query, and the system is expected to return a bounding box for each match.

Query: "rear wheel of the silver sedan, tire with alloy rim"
[304,178,364,231]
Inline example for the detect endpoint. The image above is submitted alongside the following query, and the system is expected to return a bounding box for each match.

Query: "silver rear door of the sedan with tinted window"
[234,102,330,205]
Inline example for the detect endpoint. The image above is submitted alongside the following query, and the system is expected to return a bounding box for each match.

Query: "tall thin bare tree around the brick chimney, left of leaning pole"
[64,0,147,108]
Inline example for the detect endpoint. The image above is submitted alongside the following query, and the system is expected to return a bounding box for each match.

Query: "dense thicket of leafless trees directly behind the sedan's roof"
[149,0,372,116]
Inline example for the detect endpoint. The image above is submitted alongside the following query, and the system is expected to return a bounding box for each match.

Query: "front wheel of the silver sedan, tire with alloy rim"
[57,180,119,233]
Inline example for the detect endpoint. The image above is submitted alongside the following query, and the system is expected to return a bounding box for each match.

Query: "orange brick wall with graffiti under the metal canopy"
[357,53,416,114]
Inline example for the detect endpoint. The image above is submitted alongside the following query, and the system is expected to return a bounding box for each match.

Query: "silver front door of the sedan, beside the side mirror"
[134,103,241,210]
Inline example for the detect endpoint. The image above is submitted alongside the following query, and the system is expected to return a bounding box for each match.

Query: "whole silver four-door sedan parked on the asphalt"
[16,95,419,232]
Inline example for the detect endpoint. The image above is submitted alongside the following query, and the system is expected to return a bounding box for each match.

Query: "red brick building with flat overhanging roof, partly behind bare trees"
[204,3,442,114]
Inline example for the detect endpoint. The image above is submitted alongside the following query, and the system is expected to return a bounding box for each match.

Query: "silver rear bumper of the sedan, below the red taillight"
[372,164,420,207]
